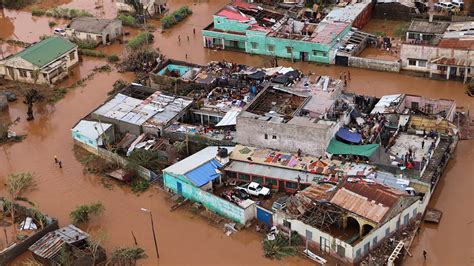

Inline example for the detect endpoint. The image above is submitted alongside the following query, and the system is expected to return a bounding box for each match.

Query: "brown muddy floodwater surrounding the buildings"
[0,0,474,265]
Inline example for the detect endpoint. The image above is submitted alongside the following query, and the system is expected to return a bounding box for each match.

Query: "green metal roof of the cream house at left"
[16,37,77,67]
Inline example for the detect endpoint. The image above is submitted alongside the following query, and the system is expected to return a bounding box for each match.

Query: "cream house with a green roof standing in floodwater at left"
[0,37,79,85]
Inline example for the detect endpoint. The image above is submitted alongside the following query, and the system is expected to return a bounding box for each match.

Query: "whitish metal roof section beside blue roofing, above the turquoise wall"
[163,146,234,175]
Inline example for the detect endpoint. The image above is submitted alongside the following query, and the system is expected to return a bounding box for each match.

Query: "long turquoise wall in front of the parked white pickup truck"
[163,172,246,224]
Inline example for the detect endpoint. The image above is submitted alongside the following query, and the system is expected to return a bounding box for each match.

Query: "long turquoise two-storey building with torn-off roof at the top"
[202,1,351,64]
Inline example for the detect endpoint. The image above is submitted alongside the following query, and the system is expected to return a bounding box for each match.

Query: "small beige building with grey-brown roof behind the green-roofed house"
[65,17,122,45]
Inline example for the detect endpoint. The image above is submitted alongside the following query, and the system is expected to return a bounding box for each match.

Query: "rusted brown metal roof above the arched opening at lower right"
[331,181,402,223]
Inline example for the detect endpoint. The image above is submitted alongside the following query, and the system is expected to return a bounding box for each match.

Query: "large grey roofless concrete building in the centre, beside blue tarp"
[236,76,343,156]
